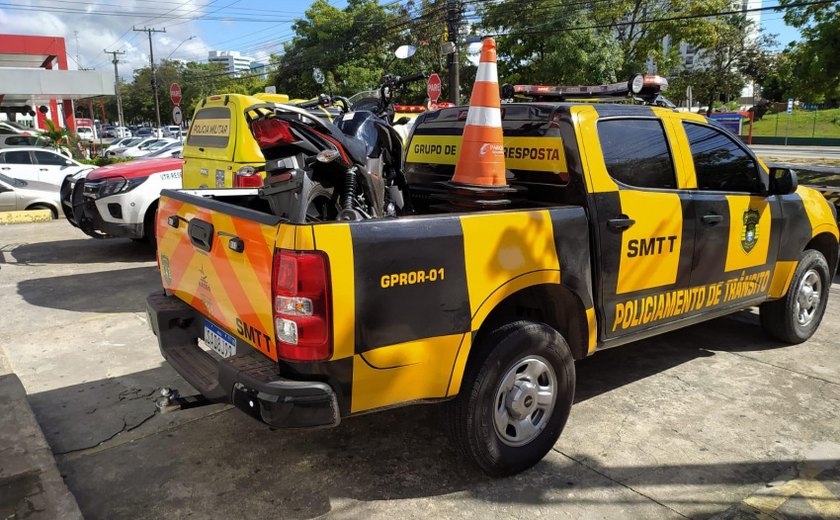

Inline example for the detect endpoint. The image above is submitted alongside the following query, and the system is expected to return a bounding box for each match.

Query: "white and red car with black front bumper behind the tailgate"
[61,158,183,242]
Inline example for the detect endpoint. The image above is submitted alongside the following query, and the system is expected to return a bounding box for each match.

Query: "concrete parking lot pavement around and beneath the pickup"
[0,221,840,520]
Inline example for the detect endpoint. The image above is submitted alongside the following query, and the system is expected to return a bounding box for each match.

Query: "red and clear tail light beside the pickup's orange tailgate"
[271,249,333,361]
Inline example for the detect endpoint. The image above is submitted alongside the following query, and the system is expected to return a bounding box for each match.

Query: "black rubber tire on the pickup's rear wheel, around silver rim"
[446,321,575,477]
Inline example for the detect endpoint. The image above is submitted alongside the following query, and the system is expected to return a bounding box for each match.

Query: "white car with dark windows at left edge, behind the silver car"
[0,146,94,187]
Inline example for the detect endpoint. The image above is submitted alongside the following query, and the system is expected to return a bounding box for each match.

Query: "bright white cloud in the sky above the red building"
[0,0,210,79]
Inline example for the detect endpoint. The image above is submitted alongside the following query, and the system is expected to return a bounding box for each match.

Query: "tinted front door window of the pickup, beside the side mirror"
[683,122,761,193]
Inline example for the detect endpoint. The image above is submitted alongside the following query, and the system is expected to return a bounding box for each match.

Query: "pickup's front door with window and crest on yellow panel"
[682,121,782,307]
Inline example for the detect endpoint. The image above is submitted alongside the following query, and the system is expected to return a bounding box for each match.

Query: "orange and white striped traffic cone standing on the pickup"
[452,38,507,189]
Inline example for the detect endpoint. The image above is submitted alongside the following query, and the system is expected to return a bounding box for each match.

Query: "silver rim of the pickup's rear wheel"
[493,356,557,447]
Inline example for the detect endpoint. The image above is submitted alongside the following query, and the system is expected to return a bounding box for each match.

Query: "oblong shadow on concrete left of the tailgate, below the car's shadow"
[17,266,161,313]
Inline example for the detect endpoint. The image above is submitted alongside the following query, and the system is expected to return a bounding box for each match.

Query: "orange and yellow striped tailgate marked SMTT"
[156,190,292,360]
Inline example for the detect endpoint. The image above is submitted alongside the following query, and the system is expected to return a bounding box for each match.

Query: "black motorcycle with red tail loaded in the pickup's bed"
[245,73,426,223]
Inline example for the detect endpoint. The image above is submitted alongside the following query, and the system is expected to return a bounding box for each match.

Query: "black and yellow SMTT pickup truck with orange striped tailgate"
[147,103,838,475]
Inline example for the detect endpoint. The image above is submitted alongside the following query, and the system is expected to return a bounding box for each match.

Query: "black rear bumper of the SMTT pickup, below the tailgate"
[146,294,341,428]
